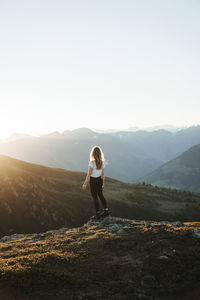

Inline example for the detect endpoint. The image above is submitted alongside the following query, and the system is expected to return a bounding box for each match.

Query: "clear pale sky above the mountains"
[0,0,200,138]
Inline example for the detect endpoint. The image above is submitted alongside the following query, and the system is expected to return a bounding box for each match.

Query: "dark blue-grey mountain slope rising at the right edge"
[141,145,200,192]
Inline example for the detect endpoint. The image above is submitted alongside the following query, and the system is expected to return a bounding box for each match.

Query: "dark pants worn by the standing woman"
[90,176,107,211]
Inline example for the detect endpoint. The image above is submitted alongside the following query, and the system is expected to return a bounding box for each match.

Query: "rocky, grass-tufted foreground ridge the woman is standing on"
[0,217,200,300]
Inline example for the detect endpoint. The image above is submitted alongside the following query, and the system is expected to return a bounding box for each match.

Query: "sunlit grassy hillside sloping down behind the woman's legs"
[0,155,200,236]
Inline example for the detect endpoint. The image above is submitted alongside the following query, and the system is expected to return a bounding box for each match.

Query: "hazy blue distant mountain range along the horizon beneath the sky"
[0,126,200,182]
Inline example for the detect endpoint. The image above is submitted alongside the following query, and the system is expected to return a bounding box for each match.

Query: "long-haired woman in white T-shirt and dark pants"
[82,146,110,219]
